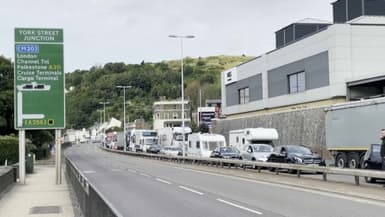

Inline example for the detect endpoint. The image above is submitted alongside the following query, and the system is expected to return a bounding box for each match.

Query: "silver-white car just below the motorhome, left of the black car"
[241,144,273,162]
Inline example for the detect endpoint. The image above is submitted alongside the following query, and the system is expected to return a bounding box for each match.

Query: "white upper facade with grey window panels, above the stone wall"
[222,16,385,118]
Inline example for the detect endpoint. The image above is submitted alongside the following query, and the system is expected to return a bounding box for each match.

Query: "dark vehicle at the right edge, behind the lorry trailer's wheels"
[361,144,382,183]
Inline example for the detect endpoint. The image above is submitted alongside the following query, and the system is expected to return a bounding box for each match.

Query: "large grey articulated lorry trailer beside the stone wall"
[325,98,385,168]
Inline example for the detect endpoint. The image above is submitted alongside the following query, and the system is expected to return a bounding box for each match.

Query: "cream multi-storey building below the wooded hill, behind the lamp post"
[153,100,191,130]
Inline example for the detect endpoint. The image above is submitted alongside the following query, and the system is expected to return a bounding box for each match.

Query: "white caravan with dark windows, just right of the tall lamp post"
[187,133,226,157]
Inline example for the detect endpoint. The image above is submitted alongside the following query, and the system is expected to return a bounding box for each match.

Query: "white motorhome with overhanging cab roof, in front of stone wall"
[229,127,278,150]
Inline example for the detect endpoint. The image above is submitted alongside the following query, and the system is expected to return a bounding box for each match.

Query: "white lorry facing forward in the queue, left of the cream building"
[129,129,159,152]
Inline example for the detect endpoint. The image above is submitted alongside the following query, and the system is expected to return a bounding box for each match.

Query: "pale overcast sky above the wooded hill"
[0,0,335,72]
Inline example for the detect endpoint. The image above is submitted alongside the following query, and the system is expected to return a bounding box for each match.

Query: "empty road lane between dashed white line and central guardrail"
[99,152,385,217]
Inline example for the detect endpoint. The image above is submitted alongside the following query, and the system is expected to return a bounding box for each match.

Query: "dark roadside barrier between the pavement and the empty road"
[66,158,122,217]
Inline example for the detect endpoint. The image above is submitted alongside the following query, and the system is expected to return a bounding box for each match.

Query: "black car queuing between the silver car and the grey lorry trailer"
[267,145,326,172]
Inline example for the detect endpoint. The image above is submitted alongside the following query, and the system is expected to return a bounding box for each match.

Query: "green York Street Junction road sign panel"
[14,28,65,129]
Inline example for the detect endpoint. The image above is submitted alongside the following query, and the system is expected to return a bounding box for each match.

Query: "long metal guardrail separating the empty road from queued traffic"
[100,146,385,185]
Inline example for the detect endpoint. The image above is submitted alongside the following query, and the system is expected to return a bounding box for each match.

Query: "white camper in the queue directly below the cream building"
[157,127,192,148]
